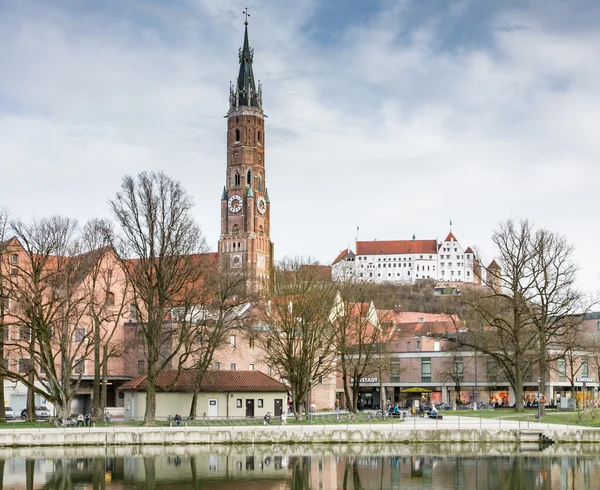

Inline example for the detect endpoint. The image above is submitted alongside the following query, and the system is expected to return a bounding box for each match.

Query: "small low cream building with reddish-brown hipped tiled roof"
[119,369,287,420]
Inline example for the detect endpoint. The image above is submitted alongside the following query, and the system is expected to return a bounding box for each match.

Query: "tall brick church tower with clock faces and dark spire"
[219,22,273,294]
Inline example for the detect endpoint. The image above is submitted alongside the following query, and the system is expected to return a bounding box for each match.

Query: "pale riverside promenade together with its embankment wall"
[0,416,600,447]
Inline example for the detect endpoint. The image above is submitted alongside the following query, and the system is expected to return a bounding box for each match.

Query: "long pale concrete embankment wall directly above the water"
[0,426,600,447]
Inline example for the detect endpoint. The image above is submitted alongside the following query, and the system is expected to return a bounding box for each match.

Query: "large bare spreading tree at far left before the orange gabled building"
[3,216,92,418]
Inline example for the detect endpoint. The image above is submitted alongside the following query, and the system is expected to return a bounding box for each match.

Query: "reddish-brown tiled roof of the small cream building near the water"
[119,369,286,392]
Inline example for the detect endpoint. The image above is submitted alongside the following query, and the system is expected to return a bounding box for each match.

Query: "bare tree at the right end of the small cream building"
[259,259,337,419]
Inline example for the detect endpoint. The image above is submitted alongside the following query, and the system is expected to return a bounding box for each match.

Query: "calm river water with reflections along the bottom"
[0,444,600,490]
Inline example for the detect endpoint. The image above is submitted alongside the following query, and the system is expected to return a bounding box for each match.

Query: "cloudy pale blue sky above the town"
[0,0,600,291]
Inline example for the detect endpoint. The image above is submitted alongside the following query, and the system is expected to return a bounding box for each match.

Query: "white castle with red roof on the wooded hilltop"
[331,232,479,284]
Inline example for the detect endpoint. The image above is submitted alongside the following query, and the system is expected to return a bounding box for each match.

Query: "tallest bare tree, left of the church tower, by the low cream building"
[110,172,206,425]
